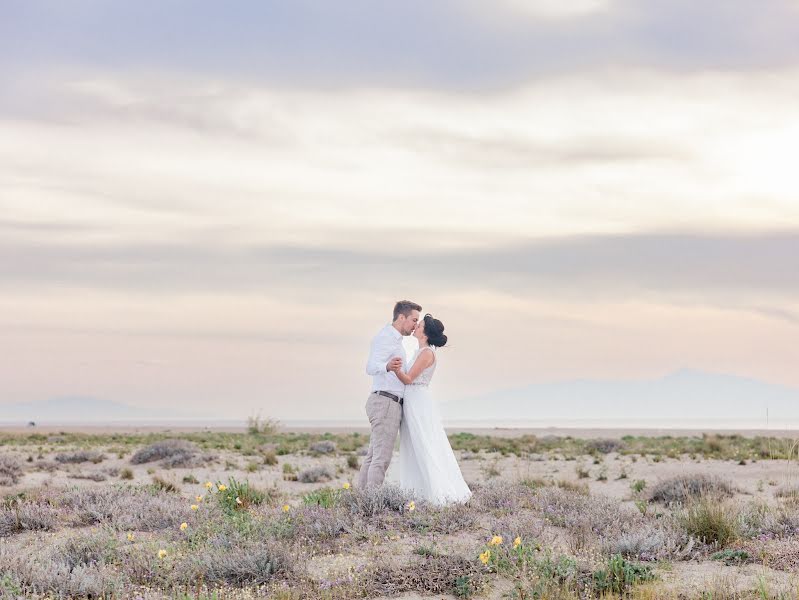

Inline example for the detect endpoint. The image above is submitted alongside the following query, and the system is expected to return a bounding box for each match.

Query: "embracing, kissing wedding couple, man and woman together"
[358,300,471,505]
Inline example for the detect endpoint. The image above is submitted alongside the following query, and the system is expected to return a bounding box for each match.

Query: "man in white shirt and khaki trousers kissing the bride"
[358,300,422,488]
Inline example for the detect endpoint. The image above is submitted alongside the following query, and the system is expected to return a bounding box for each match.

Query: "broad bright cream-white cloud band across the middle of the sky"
[0,69,799,243]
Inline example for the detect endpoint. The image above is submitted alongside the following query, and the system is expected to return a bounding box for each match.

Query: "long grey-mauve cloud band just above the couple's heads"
[0,231,799,300]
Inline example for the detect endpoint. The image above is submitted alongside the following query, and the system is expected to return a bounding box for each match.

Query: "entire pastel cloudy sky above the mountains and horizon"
[0,0,799,419]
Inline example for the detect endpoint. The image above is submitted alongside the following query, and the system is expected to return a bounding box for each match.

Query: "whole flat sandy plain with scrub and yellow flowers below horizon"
[0,419,799,600]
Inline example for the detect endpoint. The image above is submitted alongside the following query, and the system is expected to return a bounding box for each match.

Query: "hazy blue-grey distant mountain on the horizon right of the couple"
[442,369,799,426]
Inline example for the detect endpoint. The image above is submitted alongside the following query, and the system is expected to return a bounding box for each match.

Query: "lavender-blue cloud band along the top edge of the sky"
[0,0,799,89]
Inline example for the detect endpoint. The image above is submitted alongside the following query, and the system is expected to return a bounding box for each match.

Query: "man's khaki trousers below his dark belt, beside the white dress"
[358,393,402,488]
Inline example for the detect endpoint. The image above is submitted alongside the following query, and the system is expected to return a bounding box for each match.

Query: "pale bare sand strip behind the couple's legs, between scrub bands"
[4,448,799,500]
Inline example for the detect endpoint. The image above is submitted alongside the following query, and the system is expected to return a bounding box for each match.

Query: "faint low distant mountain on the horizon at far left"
[0,396,201,423]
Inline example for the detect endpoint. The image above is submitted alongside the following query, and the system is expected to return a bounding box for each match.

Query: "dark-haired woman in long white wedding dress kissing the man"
[396,314,472,505]
